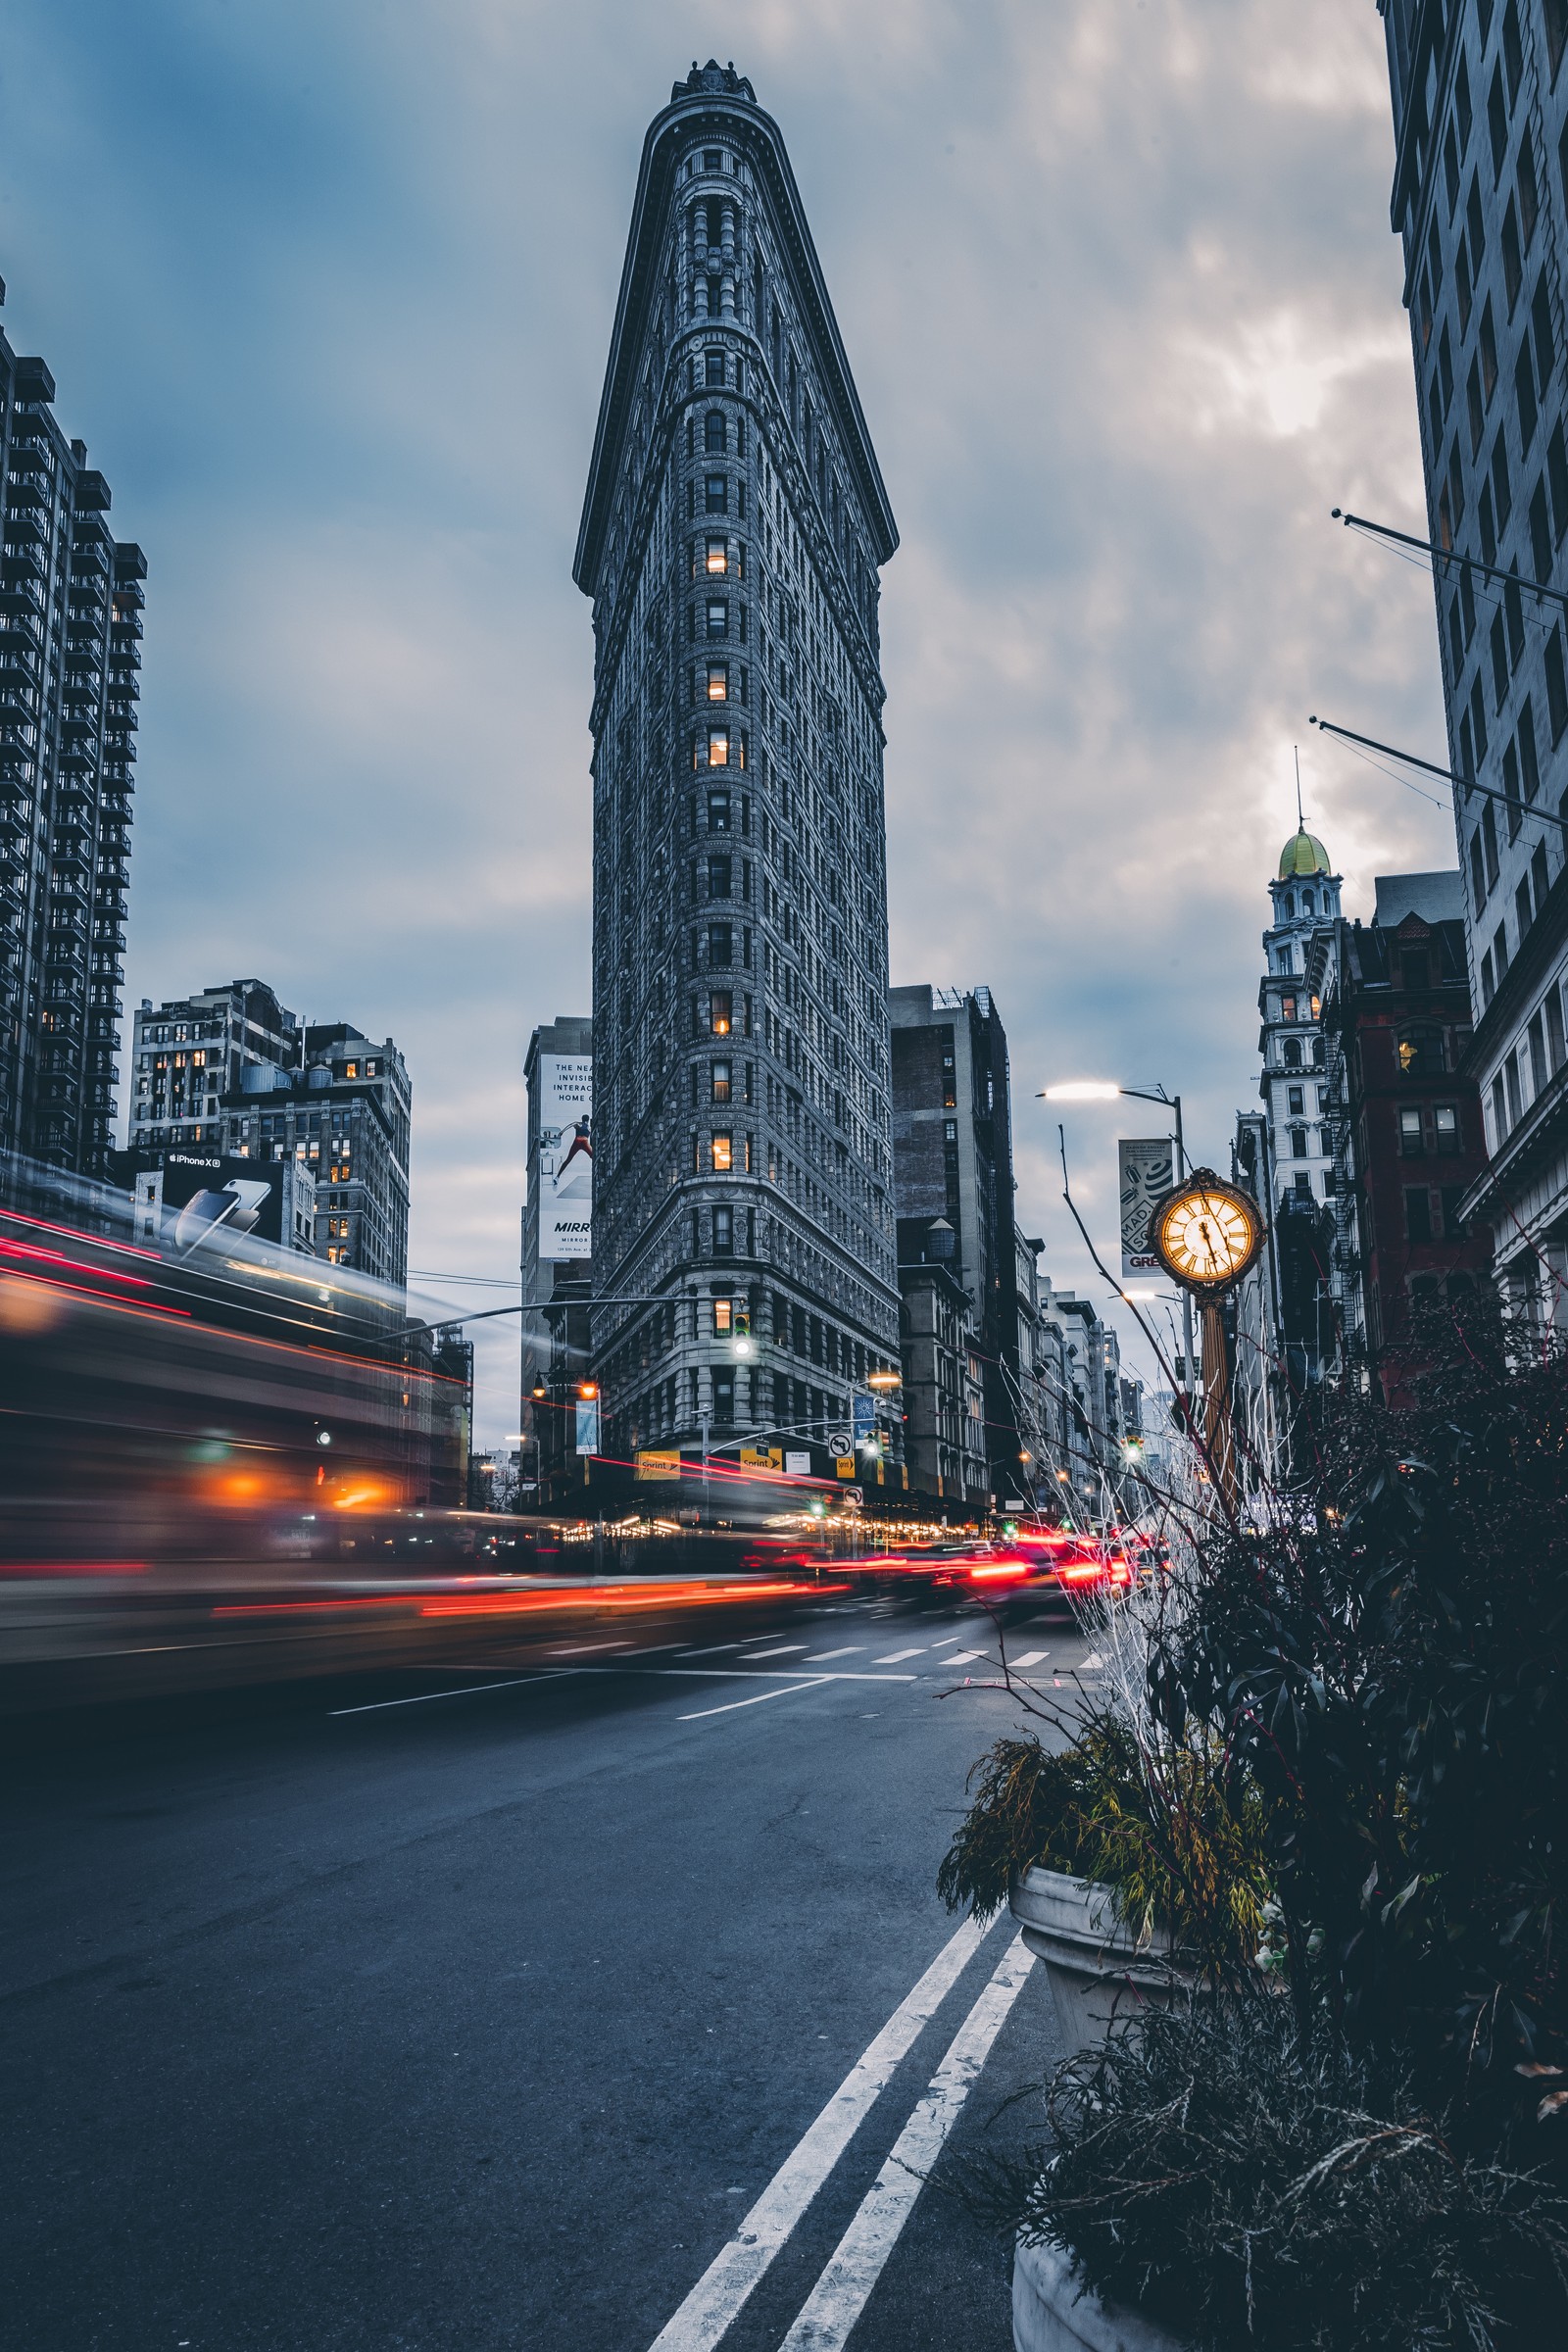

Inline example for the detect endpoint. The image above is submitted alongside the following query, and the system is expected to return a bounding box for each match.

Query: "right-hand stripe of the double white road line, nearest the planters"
[778,1936,1034,2352]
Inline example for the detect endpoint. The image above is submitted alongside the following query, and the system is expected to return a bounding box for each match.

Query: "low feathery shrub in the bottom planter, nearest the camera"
[966,1989,1568,2352]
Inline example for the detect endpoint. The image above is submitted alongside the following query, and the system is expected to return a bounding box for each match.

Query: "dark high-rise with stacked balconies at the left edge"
[0,284,148,1176]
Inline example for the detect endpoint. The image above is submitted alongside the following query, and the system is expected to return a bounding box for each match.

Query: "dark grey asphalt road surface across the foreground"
[0,1601,1084,2352]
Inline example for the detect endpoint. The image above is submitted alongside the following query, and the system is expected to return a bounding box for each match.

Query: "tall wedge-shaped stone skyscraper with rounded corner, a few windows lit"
[573,61,898,1456]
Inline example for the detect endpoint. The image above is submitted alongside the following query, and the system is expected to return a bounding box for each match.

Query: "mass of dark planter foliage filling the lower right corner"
[941,1307,1568,2352]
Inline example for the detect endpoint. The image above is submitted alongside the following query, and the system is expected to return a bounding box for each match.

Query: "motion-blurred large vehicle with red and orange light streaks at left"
[0,1164,849,1707]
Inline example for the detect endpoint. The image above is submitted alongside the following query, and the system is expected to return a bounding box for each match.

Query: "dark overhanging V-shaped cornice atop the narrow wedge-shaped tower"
[571,89,898,595]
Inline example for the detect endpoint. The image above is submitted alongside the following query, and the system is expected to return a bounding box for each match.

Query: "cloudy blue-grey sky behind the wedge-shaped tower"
[0,0,1452,1442]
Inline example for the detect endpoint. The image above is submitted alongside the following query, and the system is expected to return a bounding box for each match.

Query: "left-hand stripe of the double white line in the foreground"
[649,1919,990,2352]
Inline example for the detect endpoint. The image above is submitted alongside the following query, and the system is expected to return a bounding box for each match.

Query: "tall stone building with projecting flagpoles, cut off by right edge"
[1378,0,1568,1319]
